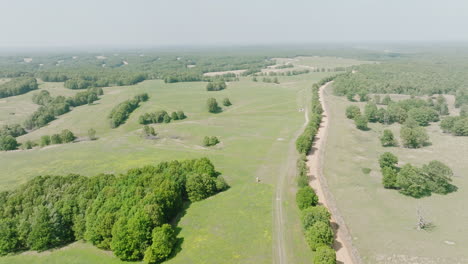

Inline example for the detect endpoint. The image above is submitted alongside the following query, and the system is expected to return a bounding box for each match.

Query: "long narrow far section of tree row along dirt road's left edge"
[296,84,323,154]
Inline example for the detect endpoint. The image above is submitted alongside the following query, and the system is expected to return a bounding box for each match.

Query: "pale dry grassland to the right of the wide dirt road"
[324,87,468,264]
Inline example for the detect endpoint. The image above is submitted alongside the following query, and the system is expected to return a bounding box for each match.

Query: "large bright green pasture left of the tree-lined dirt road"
[0,56,372,263]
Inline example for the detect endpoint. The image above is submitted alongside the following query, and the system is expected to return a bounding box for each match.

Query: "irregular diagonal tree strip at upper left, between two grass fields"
[24,88,103,129]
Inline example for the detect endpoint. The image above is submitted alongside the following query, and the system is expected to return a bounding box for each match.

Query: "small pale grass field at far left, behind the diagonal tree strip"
[0,81,78,125]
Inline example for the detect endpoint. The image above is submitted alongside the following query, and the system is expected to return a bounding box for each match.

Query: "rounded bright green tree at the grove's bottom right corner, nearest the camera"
[144,224,177,264]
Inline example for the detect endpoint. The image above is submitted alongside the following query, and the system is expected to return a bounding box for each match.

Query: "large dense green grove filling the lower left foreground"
[0,158,228,263]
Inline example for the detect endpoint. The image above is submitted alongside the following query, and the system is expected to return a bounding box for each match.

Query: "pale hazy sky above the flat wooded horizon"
[0,0,468,47]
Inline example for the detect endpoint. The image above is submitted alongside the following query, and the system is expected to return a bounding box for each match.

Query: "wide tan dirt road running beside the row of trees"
[307,83,361,264]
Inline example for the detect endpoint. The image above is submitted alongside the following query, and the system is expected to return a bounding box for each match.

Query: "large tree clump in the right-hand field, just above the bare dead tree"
[379,152,457,198]
